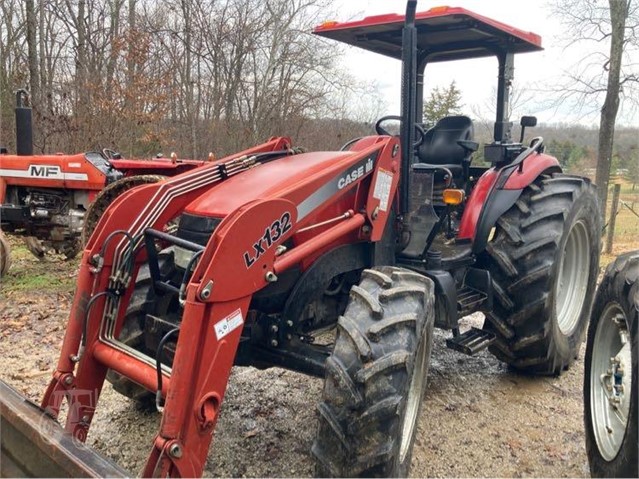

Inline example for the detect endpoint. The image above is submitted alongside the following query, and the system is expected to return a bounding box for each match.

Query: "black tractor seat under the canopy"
[417,115,474,176]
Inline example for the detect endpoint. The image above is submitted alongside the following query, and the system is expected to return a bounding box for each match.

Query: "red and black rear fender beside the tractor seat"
[457,153,561,254]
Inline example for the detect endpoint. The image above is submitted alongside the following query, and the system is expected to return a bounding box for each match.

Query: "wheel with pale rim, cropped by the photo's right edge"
[584,251,639,477]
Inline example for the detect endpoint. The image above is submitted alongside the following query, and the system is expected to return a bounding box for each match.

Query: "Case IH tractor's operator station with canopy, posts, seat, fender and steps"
[314,0,561,338]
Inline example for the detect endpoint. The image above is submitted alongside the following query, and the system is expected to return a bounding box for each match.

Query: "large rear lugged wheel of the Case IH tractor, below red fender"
[481,174,601,374]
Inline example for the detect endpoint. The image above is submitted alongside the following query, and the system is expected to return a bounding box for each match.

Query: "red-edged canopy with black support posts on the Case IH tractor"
[314,0,543,214]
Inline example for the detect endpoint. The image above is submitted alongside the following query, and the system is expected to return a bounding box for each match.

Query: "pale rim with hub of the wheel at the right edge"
[590,303,632,461]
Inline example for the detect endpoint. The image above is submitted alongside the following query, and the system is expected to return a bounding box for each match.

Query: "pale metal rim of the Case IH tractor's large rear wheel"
[555,221,590,336]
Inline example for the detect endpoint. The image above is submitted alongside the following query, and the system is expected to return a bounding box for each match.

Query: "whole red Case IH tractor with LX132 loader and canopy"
[0,0,600,477]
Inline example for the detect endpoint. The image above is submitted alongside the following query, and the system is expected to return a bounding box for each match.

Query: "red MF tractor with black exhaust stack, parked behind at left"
[0,90,203,277]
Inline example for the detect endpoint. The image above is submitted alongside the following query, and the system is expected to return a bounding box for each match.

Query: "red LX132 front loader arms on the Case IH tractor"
[42,136,399,477]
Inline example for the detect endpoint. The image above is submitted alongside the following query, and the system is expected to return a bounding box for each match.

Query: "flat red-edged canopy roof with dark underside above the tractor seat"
[313,7,542,63]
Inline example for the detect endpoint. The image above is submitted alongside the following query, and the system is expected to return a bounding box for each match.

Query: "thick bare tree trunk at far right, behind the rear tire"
[595,0,628,222]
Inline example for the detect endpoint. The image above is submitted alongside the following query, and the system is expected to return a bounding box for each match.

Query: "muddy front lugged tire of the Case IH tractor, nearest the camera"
[312,267,434,477]
